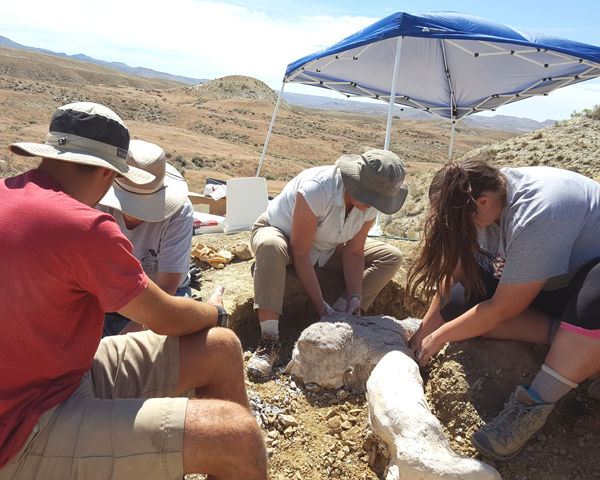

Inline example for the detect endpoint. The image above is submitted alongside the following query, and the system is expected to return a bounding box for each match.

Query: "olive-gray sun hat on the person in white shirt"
[336,149,408,215]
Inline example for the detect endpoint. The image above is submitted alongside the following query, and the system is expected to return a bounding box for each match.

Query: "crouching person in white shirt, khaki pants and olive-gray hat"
[246,150,408,380]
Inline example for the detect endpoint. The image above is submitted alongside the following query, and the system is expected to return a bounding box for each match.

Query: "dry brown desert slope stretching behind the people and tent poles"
[0,47,514,192]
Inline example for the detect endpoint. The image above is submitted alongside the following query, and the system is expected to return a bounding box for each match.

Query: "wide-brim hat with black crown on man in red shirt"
[8,102,154,184]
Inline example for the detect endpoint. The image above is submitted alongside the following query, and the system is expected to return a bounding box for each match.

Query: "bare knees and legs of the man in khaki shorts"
[179,287,267,480]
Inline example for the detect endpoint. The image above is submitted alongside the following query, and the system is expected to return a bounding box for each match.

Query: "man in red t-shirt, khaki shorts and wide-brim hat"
[0,102,266,480]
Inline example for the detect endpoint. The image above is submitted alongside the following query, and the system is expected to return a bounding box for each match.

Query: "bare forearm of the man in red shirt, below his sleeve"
[119,280,219,335]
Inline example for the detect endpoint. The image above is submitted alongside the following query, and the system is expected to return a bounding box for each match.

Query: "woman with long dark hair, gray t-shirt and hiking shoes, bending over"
[408,160,600,460]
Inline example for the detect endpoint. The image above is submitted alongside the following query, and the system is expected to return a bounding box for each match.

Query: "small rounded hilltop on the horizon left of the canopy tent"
[193,75,277,105]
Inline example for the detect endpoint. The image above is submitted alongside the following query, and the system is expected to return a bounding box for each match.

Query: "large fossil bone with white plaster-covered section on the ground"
[286,313,501,480]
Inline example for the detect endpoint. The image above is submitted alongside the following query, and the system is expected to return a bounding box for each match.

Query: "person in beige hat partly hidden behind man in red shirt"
[96,140,194,337]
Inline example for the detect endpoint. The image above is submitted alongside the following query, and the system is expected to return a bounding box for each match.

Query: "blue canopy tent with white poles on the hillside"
[257,12,600,176]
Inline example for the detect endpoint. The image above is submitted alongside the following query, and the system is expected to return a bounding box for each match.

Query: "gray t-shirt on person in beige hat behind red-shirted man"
[96,200,194,288]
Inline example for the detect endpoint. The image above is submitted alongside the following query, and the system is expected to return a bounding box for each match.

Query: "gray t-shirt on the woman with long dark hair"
[478,167,600,290]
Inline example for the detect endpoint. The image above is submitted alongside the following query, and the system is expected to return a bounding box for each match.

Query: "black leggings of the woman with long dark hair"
[440,258,600,330]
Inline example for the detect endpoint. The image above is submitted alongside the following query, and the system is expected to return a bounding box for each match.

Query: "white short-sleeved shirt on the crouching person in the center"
[267,165,377,266]
